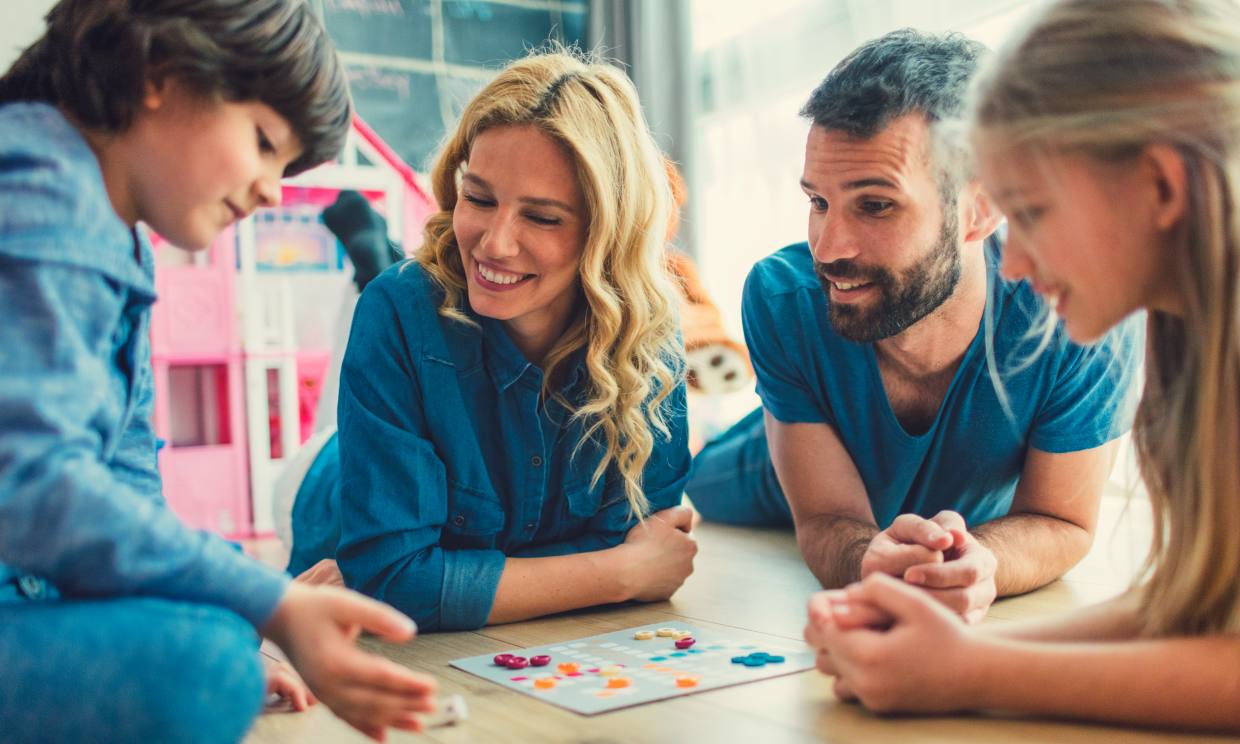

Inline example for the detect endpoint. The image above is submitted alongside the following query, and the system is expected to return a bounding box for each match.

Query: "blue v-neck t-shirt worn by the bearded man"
[743,241,1143,528]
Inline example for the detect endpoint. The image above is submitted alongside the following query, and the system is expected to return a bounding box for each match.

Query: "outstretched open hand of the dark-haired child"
[263,582,435,740]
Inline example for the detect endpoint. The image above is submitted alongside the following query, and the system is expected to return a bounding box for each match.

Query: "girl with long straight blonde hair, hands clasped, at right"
[806,0,1240,732]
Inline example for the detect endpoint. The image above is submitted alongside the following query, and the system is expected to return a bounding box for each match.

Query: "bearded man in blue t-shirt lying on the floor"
[687,30,1142,621]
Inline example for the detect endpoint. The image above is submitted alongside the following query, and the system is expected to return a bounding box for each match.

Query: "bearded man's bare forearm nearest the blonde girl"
[972,513,1094,596]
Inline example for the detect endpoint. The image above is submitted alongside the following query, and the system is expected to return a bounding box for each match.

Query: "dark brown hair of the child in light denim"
[0,0,351,175]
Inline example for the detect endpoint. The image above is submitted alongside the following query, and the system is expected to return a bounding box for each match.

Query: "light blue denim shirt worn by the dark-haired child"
[0,104,288,626]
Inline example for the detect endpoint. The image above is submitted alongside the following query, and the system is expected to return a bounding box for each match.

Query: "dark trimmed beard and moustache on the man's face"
[813,208,961,343]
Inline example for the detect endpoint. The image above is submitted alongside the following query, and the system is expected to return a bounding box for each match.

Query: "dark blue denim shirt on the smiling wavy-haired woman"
[336,262,689,630]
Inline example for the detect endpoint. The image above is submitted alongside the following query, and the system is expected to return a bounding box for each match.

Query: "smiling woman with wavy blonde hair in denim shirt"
[289,52,697,630]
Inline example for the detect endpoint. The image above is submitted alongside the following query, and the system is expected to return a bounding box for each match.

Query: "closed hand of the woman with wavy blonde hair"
[619,506,697,601]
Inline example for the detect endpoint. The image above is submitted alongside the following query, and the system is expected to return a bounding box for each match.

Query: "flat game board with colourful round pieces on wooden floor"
[451,622,815,715]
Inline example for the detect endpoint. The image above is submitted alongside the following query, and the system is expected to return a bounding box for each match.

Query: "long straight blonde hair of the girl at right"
[971,0,1240,635]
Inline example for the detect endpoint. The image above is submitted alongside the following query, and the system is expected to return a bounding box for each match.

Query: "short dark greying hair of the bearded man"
[801,29,986,193]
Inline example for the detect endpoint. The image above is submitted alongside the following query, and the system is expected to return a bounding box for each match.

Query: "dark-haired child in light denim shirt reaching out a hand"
[0,0,434,742]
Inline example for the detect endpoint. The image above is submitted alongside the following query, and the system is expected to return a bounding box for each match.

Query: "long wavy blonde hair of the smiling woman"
[415,50,683,517]
